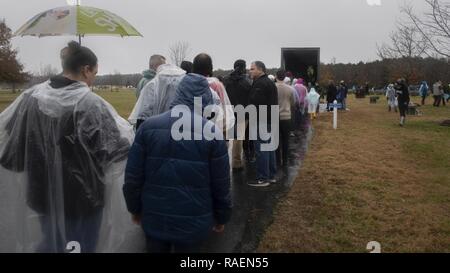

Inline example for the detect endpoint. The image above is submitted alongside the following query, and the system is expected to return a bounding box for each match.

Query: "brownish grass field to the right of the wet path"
[259,94,450,252]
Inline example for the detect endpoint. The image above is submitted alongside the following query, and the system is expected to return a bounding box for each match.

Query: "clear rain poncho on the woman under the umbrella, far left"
[0,79,144,253]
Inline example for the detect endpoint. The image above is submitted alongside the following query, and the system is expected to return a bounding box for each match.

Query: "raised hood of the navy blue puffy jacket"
[170,73,214,109]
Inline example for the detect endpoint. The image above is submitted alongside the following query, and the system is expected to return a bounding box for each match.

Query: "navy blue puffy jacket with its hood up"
[123,74,232,243]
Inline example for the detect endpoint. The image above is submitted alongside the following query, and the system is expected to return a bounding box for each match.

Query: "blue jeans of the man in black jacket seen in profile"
[255,139,277,180]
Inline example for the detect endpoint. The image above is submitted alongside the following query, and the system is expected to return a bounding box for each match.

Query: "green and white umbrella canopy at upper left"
[14,5,142,37]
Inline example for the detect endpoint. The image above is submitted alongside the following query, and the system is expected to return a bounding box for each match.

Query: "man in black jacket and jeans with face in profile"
[249,61,279,187]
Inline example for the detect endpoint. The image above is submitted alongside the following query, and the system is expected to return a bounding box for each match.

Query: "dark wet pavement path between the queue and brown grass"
[202,124,312,253]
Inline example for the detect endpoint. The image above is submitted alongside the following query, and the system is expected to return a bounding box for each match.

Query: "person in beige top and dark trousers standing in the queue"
[276,69,294,167]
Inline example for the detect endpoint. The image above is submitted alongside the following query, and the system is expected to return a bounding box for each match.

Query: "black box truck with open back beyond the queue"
[281,47,320,84]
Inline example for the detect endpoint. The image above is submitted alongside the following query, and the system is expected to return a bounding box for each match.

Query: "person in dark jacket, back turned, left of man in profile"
[224,60,252,171]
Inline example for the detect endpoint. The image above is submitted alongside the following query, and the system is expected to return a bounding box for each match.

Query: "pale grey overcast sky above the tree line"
[0,0,424,74]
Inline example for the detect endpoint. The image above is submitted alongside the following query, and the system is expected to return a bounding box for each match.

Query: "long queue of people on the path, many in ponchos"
[0,42,320,252]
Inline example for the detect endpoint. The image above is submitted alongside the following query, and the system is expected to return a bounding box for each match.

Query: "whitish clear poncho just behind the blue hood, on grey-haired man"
[128,64,186,124]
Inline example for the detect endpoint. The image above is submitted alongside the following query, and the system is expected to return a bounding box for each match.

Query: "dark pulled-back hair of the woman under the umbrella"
[63,41,98,74]
